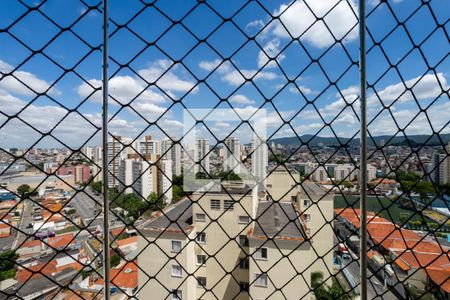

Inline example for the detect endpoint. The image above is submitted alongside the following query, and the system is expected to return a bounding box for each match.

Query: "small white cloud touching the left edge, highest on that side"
[0,60,60,96]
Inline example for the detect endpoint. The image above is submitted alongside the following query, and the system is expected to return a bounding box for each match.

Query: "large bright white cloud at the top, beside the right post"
[270,0,358,48]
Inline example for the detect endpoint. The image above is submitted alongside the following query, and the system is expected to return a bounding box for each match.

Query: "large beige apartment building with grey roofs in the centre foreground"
[138,171,333,300]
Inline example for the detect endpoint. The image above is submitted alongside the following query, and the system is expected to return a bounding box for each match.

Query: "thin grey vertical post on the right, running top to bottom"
[359,0,367,300]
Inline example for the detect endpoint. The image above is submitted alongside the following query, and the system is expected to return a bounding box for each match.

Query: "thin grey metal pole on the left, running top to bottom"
[102,0,110,300]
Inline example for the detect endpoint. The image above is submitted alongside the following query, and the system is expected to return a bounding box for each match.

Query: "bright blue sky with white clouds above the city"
[0,0,450,147]
